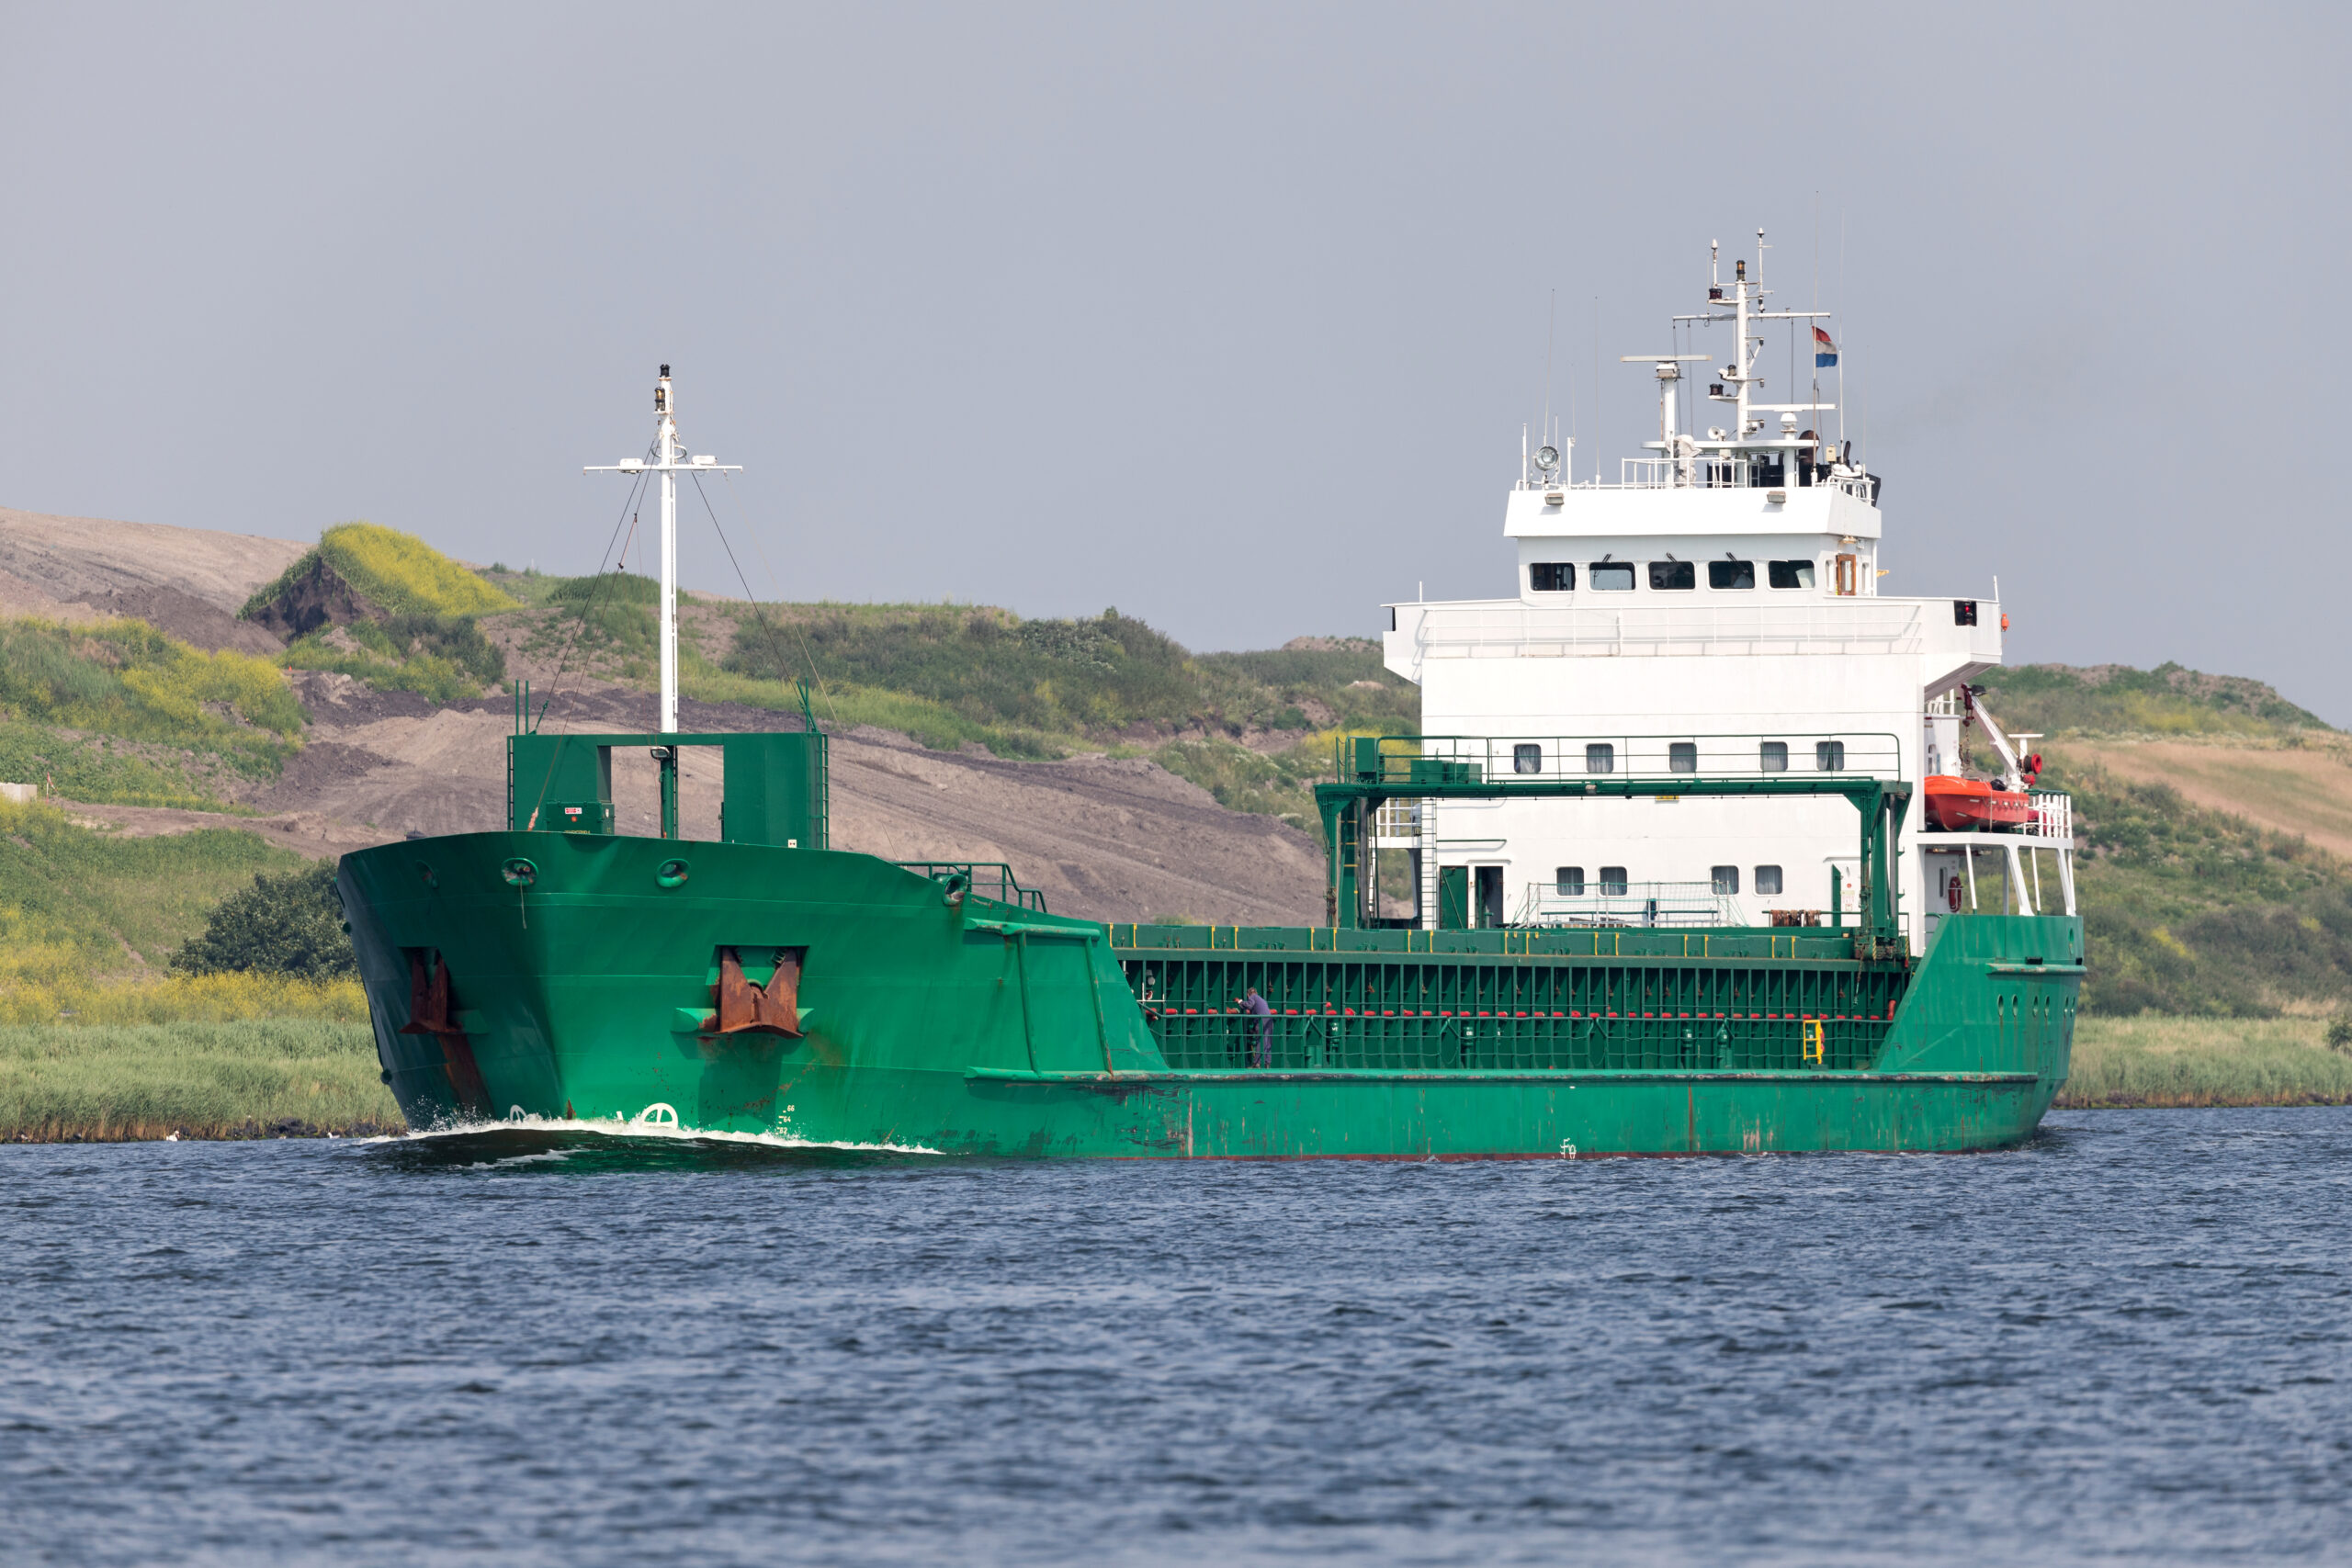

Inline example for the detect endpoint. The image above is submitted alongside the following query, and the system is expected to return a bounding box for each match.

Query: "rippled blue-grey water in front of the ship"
[0,1110,2352,1565]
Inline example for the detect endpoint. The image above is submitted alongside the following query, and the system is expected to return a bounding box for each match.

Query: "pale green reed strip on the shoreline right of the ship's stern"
[2058,1018,2352,1105]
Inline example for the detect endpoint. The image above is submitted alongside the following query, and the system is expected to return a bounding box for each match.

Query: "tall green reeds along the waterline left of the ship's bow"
[0,1018,402,1138]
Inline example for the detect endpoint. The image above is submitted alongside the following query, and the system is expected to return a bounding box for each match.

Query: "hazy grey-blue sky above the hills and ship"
[0,0,2352,724]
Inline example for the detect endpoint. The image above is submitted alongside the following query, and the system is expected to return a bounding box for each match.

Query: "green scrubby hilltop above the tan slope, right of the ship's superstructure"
[1981,663,2328,736]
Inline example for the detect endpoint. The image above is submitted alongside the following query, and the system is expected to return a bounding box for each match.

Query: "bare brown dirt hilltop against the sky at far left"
[0,508,308,653]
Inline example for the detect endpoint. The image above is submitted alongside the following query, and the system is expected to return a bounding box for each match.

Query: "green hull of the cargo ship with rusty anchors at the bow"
[341,832,2082,1159]
